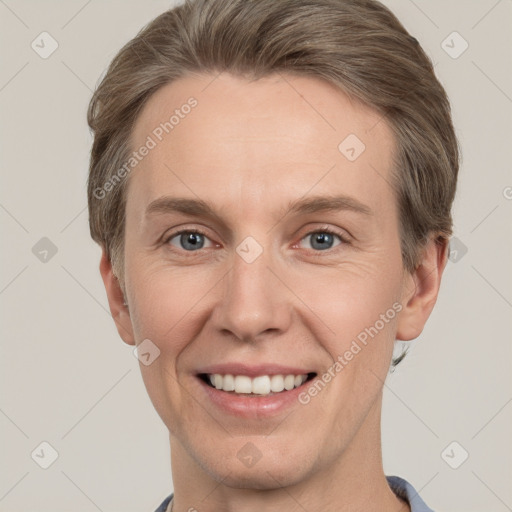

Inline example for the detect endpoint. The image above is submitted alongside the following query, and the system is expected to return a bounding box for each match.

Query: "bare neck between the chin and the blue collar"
[170,397,410,512]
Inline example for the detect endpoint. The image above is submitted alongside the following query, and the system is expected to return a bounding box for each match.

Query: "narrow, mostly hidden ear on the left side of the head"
[100,249,135,345]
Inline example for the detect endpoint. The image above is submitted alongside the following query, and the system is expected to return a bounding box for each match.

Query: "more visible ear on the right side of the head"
[396,236,449,341]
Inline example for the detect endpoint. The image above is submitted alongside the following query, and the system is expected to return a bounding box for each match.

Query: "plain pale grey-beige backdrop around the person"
[0,0,512,512]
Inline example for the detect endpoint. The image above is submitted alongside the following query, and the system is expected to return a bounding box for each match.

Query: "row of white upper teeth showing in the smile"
[208,373,308,395]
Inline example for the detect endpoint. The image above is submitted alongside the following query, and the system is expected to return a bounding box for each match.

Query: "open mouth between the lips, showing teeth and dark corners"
[197,372,317,397]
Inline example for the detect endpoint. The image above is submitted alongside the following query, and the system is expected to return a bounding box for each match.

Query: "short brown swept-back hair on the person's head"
[88,0,459,300]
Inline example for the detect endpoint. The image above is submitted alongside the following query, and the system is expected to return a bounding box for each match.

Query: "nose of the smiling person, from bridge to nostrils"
[212,244,293,343]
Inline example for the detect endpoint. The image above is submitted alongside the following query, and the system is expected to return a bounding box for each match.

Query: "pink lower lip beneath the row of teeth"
[196,377,311,418]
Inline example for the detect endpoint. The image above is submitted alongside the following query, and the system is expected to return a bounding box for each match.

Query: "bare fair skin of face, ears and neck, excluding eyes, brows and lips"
[100,73,446,512]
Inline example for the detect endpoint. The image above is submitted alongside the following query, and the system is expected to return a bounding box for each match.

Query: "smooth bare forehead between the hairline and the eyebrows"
[128,74,394,222]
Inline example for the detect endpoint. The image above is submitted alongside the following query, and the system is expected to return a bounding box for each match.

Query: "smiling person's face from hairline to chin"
[102,74,444,489]
